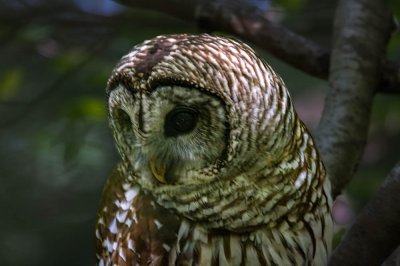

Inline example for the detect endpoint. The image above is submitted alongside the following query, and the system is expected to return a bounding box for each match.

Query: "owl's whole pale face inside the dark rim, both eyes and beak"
[109,85,229,185]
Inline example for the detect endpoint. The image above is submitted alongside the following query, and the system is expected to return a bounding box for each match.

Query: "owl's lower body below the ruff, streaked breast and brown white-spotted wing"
[96,179,330,265]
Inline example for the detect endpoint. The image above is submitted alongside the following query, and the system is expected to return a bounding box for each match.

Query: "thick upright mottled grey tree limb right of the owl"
[316,0,391,196]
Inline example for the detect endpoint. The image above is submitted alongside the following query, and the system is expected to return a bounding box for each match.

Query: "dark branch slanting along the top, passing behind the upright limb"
[118,0,400,93]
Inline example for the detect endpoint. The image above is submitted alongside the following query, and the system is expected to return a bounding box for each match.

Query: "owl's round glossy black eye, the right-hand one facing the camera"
[164,107,198,137]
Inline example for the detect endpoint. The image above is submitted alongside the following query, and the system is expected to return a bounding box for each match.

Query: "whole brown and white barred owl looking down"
[96,34,333,265]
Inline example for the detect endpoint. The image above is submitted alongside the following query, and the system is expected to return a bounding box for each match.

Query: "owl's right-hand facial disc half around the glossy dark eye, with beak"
[138,86,227,184]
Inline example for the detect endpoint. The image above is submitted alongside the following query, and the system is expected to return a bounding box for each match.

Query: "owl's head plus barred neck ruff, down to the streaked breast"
[107,34,312,230]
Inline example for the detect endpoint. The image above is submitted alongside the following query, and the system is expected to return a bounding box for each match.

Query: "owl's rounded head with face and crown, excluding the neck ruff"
[107,34,295,191]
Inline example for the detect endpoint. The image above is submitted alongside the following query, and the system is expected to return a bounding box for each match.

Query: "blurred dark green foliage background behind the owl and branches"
[0,0,400,265]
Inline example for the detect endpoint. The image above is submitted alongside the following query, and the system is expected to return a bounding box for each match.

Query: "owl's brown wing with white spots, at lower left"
[96,163,179,265]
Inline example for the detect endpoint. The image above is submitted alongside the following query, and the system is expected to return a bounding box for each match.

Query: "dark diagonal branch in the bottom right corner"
[329,161,400,266]
